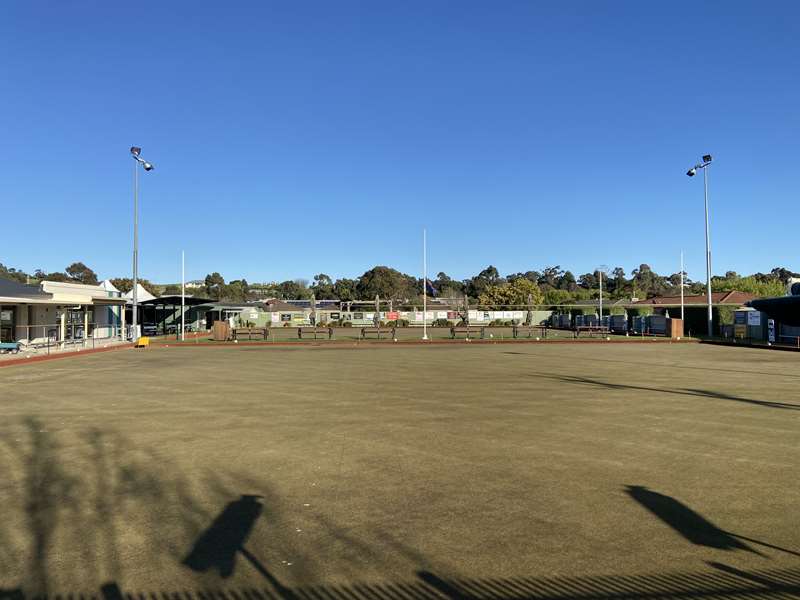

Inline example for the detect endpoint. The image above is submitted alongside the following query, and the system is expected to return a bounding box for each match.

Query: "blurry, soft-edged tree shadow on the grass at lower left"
[0,417,299,597]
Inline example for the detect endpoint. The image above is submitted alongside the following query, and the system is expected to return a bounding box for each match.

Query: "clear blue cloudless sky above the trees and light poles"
[0,0,800,282]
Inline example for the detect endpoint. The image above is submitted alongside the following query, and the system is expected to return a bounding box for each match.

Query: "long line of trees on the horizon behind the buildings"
[0,262,800,306]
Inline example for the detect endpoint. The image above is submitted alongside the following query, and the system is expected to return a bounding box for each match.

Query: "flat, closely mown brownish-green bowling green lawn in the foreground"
[0,344,800,600]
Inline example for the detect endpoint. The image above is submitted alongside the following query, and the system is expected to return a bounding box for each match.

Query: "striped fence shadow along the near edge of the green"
[0,562,800,600]
